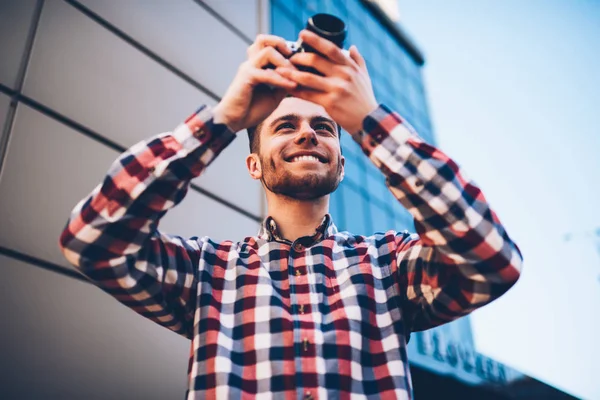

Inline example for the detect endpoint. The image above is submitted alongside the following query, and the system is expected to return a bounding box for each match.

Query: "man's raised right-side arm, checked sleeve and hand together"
[277,31,522,330]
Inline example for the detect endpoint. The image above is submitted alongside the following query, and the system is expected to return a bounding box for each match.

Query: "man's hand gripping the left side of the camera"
[213,34,297,132]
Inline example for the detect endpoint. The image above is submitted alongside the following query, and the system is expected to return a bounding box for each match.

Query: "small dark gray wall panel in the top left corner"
[0,0,36,88]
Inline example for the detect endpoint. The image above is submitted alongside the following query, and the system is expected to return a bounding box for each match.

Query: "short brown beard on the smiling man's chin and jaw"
[259,156,342,200]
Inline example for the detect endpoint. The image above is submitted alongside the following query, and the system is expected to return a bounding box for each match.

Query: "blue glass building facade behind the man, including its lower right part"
[271,0,540,394]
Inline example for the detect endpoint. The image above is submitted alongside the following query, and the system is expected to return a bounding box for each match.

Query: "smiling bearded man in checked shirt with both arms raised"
[60,31,522,399]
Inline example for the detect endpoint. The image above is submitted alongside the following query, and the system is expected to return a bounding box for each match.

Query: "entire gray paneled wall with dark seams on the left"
[0,0,262,399]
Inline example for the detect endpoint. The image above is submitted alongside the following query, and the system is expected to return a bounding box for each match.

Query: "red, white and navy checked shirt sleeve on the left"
[59,106,235,338]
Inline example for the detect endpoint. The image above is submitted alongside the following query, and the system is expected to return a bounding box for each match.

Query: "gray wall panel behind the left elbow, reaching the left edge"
[0,105,258,266]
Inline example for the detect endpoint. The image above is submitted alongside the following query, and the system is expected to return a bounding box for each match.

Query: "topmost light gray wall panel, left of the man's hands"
[76,0,247,96]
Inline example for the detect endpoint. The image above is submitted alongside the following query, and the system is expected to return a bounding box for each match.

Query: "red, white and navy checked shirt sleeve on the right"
[354,105,523,332]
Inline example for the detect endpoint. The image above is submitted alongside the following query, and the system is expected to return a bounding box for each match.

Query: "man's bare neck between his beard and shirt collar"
[267,191,329,242]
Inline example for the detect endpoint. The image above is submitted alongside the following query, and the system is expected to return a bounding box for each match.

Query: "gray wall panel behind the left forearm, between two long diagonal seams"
[24,1,261,215]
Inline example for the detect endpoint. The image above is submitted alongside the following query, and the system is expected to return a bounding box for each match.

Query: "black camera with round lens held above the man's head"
[274,13,348,75]
